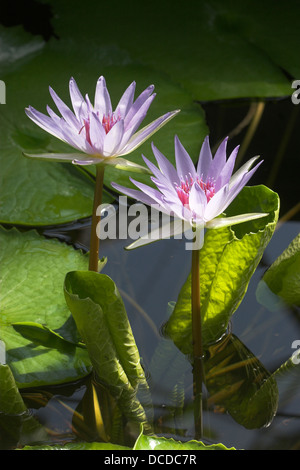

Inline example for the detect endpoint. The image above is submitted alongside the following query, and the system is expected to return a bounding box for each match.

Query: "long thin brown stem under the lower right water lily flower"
[192,249,203,440]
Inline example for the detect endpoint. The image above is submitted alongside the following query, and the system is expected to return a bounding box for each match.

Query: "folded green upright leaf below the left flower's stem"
[64,271,152,428]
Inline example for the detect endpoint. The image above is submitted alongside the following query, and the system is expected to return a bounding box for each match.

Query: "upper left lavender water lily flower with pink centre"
[25,76,179,169]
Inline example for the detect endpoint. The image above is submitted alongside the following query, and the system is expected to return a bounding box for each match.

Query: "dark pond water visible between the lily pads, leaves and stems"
[4,96,300,449]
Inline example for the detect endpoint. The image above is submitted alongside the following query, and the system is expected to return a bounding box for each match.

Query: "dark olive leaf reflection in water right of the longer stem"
[205,334,278,429]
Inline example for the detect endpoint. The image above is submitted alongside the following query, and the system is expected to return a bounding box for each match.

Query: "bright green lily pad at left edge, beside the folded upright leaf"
[0,228,91,388]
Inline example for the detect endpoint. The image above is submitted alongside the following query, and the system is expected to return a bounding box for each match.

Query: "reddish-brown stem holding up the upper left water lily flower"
[89,165,104,272]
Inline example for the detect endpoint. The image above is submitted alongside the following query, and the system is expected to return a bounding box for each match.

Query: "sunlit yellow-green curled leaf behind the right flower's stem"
[165,186,279,354]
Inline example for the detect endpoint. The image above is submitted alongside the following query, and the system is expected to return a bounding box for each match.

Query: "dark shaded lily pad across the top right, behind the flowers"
[48,0,292,101]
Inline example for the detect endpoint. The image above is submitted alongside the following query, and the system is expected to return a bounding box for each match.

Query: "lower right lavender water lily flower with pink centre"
[112,136,268,248]
